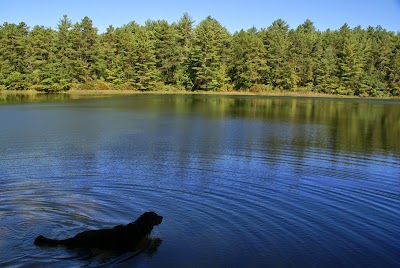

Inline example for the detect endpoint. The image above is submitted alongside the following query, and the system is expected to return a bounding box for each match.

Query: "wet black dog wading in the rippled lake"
[35,212,163,251]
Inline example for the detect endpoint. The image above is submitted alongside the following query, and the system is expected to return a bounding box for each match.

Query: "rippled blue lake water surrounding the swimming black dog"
[0,95,400,267]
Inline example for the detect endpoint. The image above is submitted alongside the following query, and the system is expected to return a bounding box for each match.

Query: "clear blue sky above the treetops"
[0,0,400,33]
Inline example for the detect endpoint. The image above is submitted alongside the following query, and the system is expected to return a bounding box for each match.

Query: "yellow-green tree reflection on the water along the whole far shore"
[0,94,400,154]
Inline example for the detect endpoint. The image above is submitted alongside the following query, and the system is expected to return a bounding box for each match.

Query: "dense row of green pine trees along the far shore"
[0,14,400,96]
